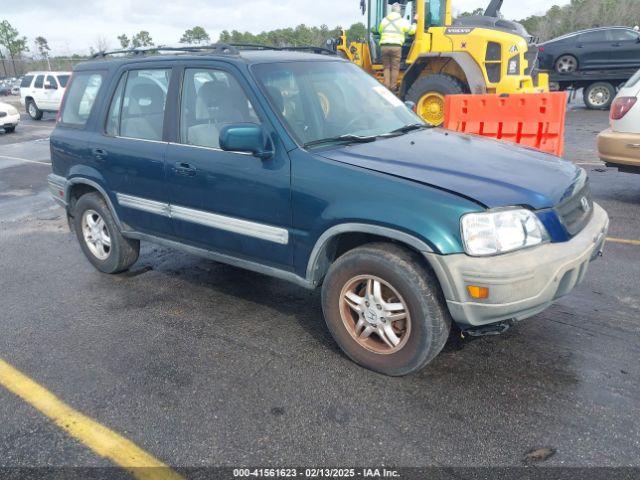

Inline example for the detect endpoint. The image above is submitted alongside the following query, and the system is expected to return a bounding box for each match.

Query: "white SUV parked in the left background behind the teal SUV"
[20,72,71,120]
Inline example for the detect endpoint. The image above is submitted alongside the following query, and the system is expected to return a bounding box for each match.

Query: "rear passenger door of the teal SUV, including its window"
[87,63,172,237]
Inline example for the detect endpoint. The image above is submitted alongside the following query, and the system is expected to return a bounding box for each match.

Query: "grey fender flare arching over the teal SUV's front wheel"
[306,223,434,286]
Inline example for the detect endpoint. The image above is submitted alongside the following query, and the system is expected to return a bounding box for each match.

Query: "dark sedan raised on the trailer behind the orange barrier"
[538,27,640,74]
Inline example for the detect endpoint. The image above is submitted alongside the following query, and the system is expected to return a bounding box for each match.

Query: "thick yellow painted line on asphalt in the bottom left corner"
[0,359,183,480]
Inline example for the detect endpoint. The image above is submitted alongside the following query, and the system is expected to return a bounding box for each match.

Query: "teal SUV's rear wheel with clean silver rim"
[73,193,140,274]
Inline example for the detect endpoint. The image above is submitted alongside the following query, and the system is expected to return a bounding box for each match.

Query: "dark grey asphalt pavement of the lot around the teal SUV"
[0,107,640,476]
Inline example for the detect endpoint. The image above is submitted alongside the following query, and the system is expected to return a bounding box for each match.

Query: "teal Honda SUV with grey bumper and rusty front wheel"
[49,46,609,375]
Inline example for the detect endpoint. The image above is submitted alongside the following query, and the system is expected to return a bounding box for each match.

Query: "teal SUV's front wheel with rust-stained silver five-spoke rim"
[322,243,451,376]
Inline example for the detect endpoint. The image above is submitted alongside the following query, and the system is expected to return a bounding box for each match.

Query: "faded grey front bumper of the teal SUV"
[425,203,609,327]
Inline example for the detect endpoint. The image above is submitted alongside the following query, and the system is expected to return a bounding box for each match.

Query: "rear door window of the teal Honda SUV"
[117,69,171,141]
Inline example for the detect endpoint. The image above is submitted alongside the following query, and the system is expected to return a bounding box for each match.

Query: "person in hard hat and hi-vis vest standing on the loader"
[378,3,416,91]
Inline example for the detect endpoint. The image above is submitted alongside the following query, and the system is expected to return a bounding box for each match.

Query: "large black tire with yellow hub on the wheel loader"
[406,74,465,126]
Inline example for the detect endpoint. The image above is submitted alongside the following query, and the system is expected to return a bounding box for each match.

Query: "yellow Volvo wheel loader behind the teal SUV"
[336,0,549,125]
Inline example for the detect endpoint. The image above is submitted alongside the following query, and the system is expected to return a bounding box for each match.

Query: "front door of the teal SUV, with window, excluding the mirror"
[167,63,292,269]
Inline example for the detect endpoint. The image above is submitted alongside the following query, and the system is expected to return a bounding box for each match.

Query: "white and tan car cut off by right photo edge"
[598,66,640,173]
